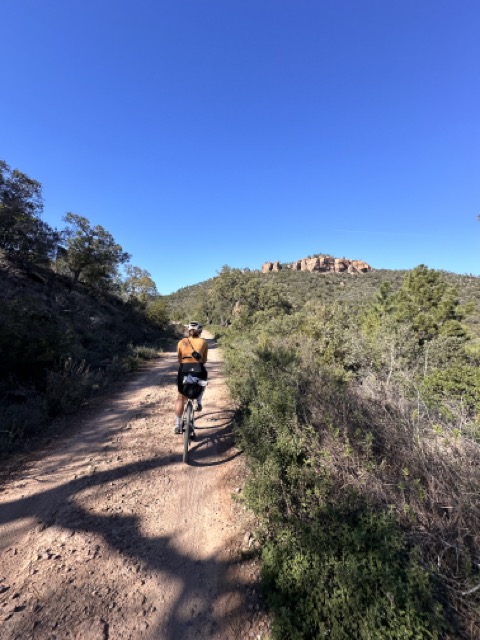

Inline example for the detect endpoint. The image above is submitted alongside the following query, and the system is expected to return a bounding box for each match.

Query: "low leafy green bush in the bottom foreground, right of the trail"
[262,505,445,640]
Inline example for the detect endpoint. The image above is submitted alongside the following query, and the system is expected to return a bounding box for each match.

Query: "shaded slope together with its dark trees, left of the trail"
[0,161,168,451]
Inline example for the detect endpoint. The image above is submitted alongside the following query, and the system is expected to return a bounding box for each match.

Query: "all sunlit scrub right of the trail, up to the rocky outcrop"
[169,265,480,640]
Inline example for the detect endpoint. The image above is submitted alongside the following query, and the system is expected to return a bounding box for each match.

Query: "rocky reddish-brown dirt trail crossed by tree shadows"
[0,340,267,640]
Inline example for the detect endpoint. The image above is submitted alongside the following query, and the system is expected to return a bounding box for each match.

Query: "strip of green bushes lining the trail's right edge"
[227,338,444,640]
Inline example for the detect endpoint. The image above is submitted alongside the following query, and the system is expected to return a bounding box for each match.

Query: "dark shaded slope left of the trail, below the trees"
[0,252,163,450]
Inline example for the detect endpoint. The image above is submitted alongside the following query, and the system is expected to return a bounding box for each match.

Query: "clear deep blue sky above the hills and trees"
[0,0,480,293]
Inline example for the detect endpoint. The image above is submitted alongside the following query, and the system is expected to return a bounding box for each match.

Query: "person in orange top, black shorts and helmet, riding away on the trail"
[174,320,208,433]
